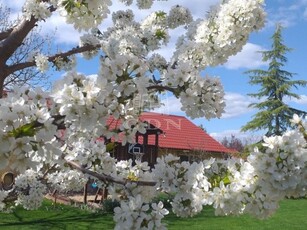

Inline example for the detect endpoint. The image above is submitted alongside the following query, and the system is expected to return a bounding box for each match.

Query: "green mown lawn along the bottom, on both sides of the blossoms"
[0,199,307,230]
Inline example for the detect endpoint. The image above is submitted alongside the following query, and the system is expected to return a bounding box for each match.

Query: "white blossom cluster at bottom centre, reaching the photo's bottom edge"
[98,160,169,229]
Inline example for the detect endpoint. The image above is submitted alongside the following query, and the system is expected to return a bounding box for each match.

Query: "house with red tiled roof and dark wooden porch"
[113,112,232,165]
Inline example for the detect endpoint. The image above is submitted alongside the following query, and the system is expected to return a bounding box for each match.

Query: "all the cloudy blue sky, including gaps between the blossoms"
[0,0,307,139]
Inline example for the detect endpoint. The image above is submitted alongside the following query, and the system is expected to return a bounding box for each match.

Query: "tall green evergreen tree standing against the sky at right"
[242,25,307,136]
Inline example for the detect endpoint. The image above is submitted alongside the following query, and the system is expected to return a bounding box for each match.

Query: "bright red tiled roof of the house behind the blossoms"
[141,112,231,153]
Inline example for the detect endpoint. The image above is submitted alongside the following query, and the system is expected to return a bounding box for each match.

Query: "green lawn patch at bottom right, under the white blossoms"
[166,199,307,230]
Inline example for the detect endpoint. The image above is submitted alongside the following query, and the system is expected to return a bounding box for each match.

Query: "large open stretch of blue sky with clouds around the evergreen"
[203,0,307,137]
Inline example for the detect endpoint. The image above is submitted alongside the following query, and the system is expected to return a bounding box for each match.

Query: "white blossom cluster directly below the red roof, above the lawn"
[153,155,212,217]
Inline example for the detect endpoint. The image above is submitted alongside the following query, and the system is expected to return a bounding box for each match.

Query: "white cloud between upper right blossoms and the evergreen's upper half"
[223,43,267,69]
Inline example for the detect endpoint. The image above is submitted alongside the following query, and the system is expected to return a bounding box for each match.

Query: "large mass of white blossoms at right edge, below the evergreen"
[200,115,307,218]
